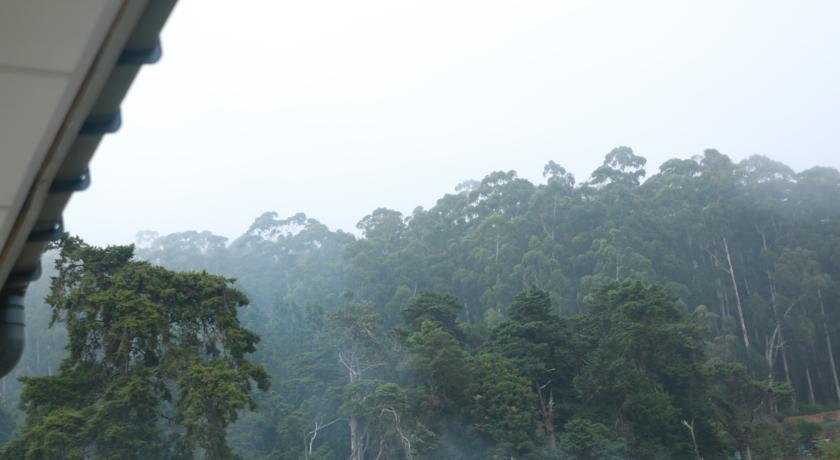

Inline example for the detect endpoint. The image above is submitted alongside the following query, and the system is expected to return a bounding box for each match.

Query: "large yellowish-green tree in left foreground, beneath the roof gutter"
[0,238,269,459]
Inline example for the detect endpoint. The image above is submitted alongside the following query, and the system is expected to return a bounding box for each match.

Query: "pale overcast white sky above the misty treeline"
[65,0,840,248]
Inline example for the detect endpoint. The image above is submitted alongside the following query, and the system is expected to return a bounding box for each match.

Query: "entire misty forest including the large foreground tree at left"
[0,147,840,460]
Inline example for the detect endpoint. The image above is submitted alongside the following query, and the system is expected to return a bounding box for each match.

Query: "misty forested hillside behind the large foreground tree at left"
[0,147,840,460]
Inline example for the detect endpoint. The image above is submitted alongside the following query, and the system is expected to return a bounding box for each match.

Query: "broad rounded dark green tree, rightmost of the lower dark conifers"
[575,281,714,458]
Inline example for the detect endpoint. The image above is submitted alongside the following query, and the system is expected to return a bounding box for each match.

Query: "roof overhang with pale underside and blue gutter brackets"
[0,0,176,376]
